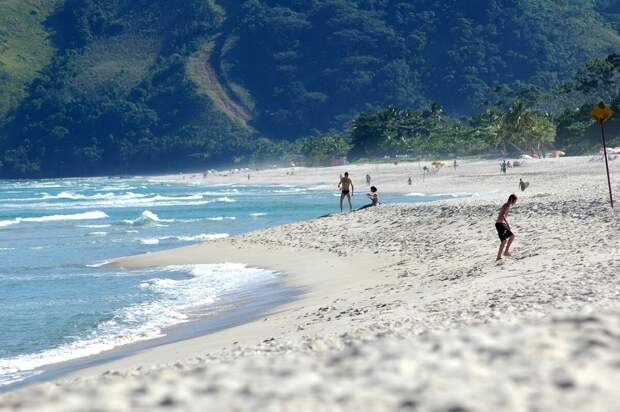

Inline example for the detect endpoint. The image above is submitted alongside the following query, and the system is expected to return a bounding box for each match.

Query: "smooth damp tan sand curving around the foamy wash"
[55,238,400,381]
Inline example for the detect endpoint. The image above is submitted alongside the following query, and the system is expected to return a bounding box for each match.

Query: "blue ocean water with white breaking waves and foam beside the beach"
[0,178,467,388]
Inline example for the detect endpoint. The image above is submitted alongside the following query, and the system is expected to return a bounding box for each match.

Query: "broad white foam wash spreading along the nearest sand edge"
[0,263,277,386]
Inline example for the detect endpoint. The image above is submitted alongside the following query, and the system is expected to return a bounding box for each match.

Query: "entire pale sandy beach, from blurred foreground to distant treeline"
[0,158,620,412]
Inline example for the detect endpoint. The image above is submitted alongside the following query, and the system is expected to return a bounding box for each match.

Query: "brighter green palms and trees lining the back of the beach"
[260,101,556,165]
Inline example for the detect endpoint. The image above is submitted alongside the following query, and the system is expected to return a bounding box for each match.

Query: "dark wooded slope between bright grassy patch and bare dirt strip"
[2,0,250,176]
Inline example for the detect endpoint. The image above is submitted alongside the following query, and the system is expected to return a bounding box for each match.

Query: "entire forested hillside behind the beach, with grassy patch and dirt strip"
[0,0,620,177]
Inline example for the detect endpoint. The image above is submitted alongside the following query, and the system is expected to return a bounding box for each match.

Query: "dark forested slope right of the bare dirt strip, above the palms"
[230,0,620,138]
